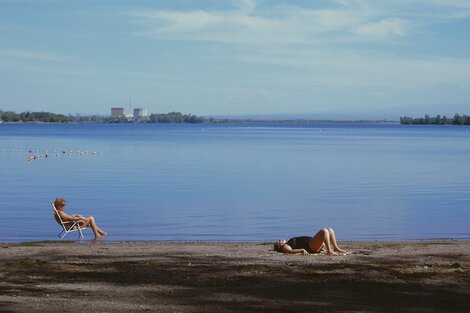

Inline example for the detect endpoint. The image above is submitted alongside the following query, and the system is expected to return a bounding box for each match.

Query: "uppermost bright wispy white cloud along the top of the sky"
[130,0,409,45]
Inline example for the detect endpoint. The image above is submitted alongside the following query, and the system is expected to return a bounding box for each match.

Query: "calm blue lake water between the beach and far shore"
[0,124,470,242]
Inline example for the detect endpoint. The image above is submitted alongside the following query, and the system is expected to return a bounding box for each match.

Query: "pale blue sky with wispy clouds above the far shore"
[0,0,470,119]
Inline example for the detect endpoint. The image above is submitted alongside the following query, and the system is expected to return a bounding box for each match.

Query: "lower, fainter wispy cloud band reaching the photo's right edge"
[237,44,470,92]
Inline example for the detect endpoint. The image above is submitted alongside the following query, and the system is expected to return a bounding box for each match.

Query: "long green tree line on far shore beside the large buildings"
[0,111,205,123]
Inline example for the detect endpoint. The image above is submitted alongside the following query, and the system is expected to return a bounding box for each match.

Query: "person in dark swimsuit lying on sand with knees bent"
[274,228,351,255]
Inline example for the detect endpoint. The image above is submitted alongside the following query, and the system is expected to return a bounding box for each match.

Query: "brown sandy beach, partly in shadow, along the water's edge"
[0,240,470,312]
